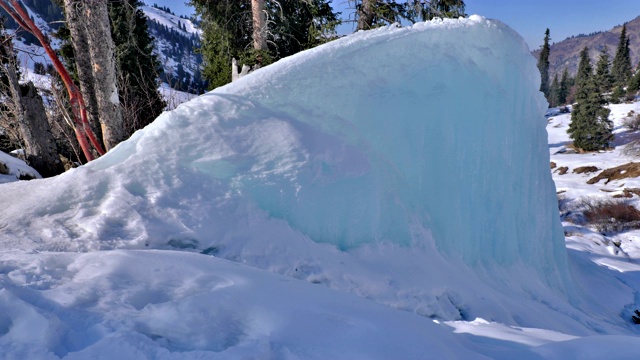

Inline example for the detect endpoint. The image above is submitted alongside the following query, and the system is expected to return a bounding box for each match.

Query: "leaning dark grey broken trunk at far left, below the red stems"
[5,64,64,177]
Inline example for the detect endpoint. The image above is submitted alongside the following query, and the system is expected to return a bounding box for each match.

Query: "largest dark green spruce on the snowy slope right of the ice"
[567,47,613,151]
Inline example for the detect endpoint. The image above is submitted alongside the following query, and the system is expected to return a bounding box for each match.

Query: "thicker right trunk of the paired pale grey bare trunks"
[64,0,124,151]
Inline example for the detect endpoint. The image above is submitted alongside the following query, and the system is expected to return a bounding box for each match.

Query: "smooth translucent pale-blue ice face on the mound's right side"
[208,17,566,280]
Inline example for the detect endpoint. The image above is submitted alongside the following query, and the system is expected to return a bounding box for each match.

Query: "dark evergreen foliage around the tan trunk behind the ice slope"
[190,0,340,88]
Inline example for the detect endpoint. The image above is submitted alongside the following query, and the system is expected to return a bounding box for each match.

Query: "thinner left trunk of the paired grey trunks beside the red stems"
[64,0,104,145]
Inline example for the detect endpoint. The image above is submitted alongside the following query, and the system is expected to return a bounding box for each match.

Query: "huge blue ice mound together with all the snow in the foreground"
[0,16,640,359]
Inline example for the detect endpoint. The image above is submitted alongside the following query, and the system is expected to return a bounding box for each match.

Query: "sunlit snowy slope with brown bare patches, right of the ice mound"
[547,102,640,258]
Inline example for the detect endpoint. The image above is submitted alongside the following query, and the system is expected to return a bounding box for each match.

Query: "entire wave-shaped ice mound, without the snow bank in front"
[0,16,566,285]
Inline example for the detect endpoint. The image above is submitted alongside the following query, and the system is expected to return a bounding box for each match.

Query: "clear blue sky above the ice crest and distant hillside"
[145,0,640,50]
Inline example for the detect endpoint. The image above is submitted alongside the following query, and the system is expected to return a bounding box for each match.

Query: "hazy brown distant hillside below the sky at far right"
[533,16,640,78]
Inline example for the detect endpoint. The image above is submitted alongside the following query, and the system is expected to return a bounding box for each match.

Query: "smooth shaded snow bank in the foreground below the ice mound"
[0,251,482,360]
